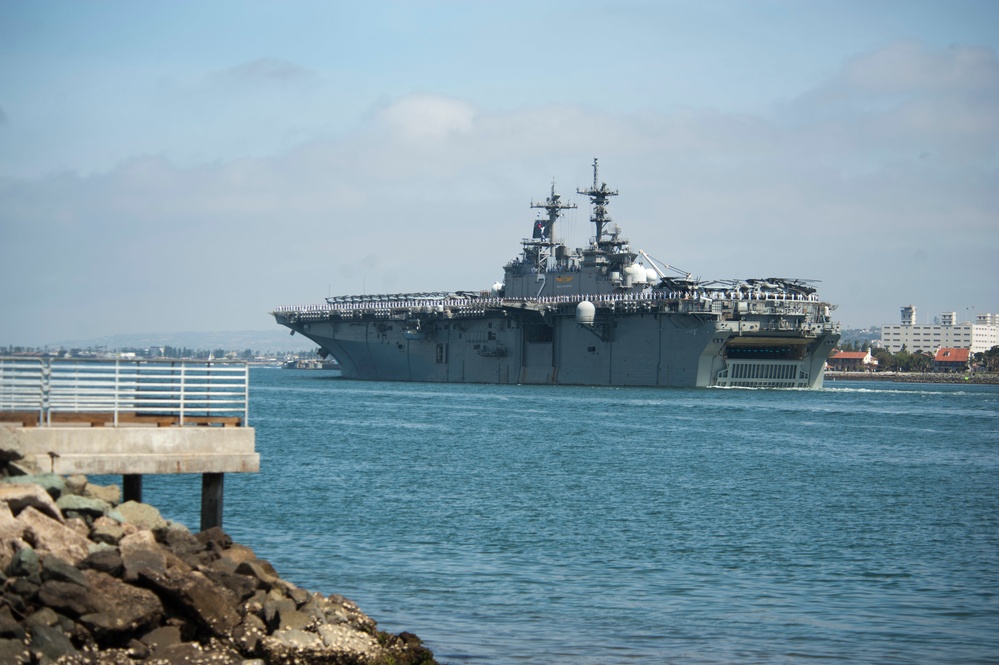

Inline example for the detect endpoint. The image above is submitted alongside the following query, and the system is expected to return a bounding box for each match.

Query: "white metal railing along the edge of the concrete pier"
[0,357,250,425]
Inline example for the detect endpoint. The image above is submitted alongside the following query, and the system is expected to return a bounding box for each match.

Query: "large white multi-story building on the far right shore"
[881,305,999,353]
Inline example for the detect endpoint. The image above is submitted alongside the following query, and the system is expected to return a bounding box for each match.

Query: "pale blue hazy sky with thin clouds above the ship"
[0,0,999,346]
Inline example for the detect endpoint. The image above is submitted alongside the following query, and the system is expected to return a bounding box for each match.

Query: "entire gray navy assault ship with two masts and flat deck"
[272,160,840,388]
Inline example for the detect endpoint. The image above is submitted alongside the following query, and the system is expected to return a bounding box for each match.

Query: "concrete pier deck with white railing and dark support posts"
[0,358,260,530]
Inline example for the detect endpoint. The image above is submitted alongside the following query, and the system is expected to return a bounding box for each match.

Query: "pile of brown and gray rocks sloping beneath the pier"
[0,475,436,665]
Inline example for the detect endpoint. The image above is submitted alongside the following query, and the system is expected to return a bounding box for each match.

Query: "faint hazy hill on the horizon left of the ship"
[46,328,316,353]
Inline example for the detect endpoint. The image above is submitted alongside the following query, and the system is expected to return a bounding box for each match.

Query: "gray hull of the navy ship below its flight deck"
[277,308,839,388]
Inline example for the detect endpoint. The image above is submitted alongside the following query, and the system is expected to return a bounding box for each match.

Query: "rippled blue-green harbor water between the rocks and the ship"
[121,368,999,665]
